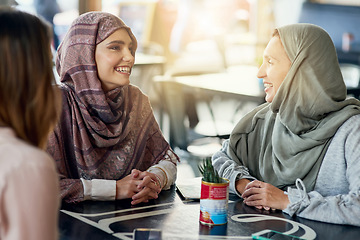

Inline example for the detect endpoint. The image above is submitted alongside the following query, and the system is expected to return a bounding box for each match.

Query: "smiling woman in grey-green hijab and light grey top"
[212,24,360,226]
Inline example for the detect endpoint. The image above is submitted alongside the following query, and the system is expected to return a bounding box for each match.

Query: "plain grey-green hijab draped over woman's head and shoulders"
[228,24,360,190]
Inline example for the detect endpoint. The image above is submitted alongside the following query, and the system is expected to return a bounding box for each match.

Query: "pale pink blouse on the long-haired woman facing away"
[0,127,60,240]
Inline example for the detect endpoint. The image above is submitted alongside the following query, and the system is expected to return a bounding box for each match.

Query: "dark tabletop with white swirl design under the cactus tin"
[59,186,360,240]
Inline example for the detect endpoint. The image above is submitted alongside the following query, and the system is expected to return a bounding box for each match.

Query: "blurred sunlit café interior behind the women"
[7,0,360,239]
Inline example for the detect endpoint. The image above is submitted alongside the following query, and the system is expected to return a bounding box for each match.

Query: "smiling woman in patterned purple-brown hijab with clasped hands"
[47,12,179,204]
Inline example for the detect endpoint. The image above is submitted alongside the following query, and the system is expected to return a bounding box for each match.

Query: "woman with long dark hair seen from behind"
[0,7,61,240]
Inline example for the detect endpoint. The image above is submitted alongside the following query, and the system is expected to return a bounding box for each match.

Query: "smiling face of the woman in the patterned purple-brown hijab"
[95,28,135,92]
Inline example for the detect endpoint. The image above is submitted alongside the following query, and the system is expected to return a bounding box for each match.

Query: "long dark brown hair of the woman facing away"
[0,8,61,148]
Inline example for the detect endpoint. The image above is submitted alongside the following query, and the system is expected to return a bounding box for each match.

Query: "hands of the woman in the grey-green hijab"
[241,180,289,210]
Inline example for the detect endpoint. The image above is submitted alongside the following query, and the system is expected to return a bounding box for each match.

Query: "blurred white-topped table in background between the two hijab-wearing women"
[154,65,265,150]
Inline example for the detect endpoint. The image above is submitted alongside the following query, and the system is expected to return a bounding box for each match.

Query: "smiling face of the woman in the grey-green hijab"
[257,36,291,102]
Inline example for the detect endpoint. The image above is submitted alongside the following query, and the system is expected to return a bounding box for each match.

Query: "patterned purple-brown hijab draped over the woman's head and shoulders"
[47,12,176,202]
